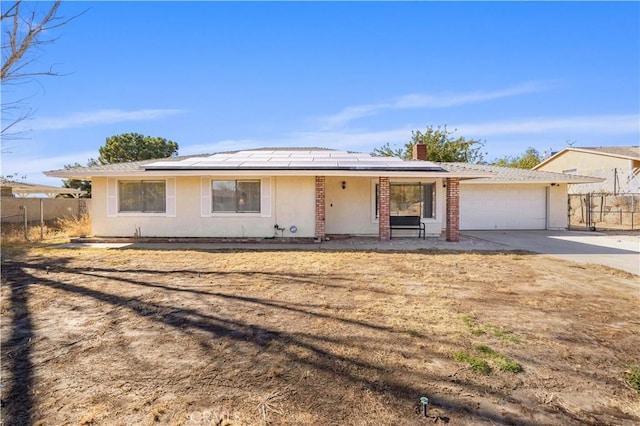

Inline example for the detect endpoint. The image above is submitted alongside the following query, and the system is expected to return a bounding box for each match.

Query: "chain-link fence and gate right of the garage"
[568,193,640,231]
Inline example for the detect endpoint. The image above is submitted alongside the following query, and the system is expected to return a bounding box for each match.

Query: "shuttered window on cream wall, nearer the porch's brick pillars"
[211,180,260,213]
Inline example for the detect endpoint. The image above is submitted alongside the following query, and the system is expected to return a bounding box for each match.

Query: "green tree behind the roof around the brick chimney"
[372,126,484,163]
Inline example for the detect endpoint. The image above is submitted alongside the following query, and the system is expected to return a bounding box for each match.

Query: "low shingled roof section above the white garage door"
[439,163,603,183]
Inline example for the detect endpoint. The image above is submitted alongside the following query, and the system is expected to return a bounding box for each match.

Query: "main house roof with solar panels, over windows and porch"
[45,148,490,179]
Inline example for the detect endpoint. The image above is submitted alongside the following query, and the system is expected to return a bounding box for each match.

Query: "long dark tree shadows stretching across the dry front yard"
[3,253,580,426]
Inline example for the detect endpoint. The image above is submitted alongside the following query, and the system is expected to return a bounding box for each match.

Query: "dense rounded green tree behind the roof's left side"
[98,133,178,164]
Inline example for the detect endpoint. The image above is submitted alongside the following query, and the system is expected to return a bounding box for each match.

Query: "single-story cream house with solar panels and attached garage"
[45,145,594,241]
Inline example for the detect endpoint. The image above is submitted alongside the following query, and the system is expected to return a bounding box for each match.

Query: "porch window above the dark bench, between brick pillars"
[376,183,436,219]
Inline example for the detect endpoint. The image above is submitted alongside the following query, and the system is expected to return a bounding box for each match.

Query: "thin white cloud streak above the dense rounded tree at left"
[20,109,185,130]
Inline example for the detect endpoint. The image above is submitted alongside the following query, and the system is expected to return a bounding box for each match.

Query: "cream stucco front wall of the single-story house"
[92,176,567,238]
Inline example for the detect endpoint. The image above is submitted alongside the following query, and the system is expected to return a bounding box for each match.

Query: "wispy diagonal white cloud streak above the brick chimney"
[320,81,552,130]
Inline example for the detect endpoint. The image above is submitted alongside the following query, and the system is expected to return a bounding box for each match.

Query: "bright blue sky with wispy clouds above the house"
[2,2,640,186]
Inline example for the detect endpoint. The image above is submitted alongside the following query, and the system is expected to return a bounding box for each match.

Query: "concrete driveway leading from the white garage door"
[462,231,640,275]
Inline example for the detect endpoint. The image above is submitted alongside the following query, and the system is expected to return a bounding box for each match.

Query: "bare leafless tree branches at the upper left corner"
[0,0,79,143]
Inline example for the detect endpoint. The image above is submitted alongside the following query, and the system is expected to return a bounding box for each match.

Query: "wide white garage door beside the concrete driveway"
[460,184,547,230]
